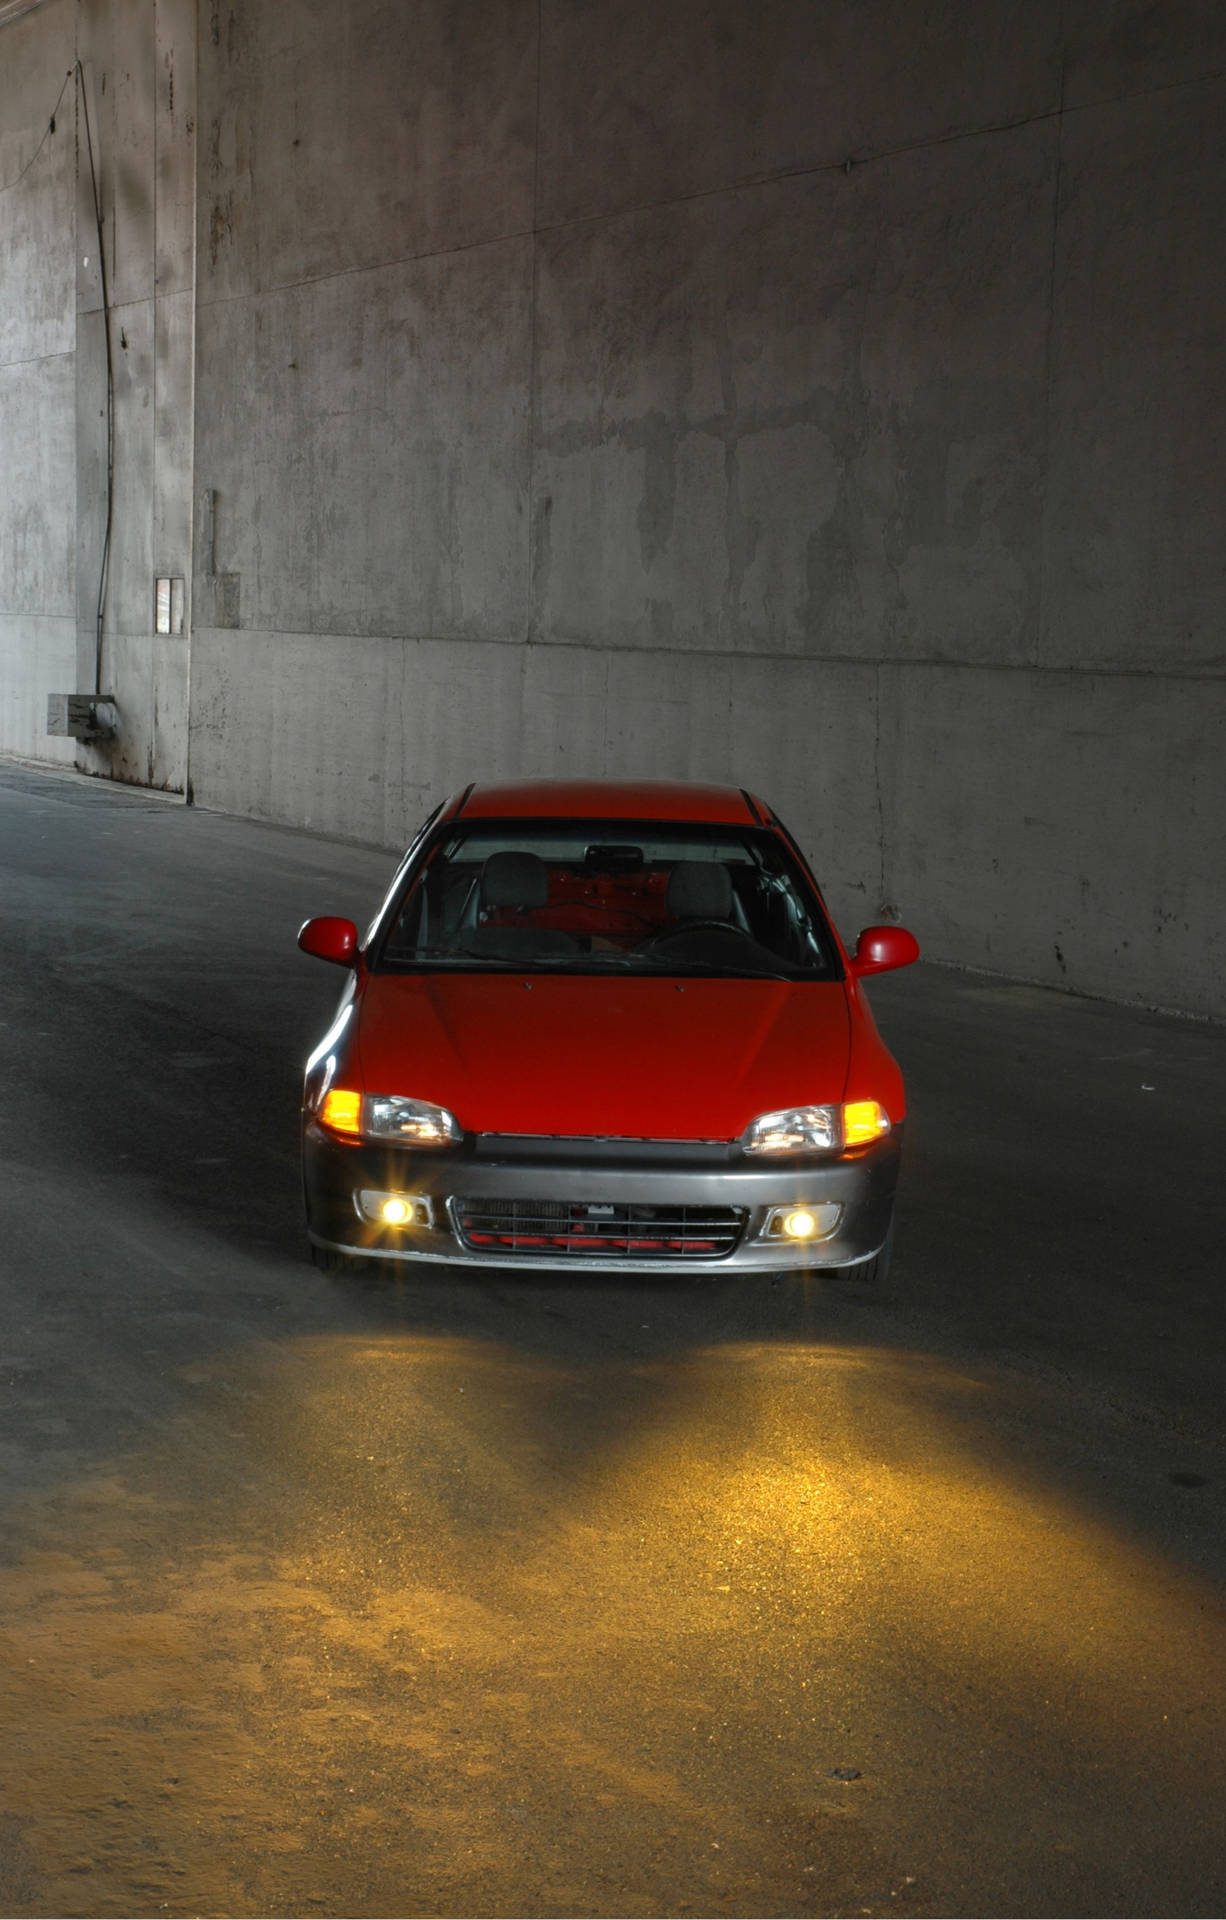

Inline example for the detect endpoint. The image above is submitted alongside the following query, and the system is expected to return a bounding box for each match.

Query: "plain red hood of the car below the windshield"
[359,973,850,1140]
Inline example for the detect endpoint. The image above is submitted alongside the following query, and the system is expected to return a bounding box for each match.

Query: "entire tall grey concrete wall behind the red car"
[0,0,1226,1014]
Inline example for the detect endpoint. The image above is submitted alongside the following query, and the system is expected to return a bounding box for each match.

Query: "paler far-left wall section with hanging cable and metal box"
[0,0,196,791]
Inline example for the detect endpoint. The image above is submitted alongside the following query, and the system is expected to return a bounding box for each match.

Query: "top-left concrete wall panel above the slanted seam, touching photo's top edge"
[200,0,537,303]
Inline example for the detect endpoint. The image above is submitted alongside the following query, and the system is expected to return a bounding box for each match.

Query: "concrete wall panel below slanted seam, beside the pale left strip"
[196,240,531,637]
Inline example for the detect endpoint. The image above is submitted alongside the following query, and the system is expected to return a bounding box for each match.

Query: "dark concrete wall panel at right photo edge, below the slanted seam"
[1042,79,1226,672]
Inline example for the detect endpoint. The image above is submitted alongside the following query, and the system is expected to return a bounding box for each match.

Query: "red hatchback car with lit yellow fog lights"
[297,781,919,1277]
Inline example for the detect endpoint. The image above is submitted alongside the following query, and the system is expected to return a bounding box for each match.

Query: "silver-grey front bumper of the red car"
[303,1117,902,1275]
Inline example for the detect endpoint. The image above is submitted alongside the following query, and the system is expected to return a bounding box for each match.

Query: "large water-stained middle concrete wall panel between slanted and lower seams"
[533,125,1055,660]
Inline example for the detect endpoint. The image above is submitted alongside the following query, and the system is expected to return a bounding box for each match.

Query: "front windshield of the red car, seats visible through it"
[370,820,838,979]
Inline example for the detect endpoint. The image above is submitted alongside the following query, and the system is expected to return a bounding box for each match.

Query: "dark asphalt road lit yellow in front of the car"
[0,762,1226,1916]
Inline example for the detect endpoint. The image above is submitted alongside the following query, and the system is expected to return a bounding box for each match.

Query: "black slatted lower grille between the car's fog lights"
[451,1200,744,1260]
